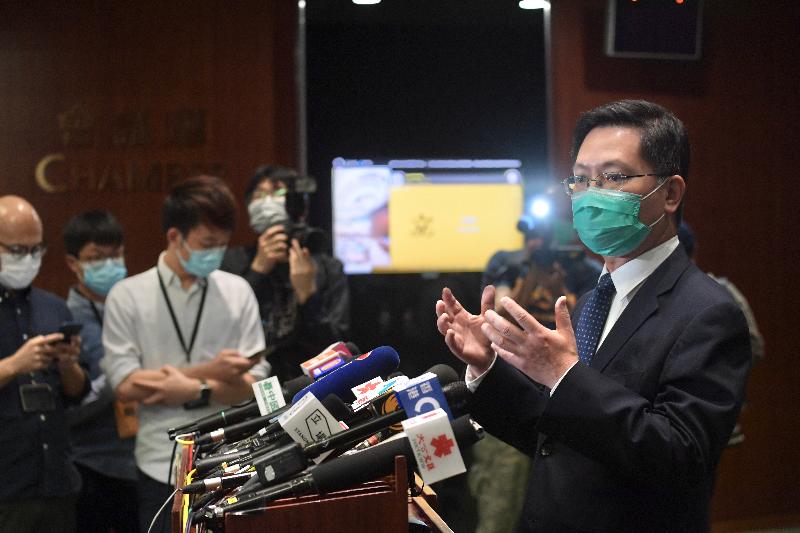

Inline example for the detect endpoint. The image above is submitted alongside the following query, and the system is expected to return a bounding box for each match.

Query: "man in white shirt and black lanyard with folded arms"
[102,176,270,531]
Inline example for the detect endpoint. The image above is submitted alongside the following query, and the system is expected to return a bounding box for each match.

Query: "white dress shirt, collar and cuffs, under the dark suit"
[465,235,680,390]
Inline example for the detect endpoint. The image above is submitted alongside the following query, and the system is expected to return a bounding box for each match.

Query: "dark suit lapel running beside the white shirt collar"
[591,246,691,372]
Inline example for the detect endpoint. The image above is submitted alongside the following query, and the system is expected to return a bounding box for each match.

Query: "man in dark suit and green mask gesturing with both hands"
[436,101,750,532]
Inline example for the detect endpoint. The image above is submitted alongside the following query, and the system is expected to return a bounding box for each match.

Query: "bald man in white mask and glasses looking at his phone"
[0,196,88,533]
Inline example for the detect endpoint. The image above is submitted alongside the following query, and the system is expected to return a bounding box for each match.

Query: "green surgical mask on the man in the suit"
[572,180,667,257]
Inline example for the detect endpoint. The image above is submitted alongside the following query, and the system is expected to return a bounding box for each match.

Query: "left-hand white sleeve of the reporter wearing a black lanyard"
[100,286,142,390]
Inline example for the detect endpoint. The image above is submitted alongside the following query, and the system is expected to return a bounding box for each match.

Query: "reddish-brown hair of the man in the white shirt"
[161,175,236,236]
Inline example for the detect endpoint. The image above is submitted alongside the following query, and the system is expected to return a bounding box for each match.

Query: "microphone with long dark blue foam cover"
[292,346,400,403]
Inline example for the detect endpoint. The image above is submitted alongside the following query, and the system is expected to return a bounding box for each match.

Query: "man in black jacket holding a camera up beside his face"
[221,165,350,382]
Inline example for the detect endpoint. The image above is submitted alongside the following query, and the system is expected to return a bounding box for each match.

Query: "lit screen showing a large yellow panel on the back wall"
[331,158,523,274]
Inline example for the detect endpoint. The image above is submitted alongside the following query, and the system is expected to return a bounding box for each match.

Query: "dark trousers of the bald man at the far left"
[0,496,76,533]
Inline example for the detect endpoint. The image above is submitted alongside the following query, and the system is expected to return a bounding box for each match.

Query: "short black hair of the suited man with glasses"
[571,100,691,222]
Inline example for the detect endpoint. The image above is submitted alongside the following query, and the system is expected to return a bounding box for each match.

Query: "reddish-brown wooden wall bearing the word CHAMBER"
[0,0,296,294]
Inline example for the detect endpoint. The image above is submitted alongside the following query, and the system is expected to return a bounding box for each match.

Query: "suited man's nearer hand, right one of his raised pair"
[481,296,578,389]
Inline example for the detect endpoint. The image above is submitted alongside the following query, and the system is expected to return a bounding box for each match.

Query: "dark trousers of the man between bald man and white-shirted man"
[75,464,139,533]
